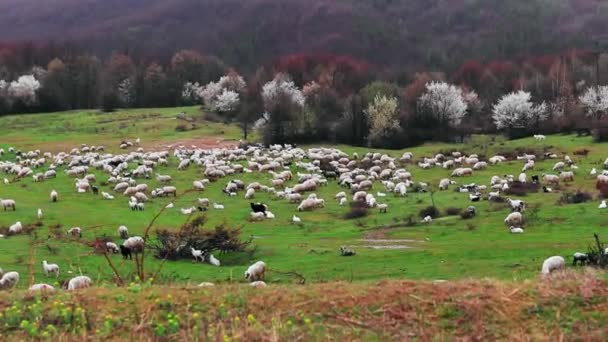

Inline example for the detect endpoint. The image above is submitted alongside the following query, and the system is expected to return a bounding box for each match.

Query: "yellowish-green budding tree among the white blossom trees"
[365,95,400,145]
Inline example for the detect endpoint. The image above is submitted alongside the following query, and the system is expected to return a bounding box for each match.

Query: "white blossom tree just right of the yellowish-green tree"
[418,82,468,125]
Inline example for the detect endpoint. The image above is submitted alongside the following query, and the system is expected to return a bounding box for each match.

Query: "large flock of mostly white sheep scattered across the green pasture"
[0,137,608,289]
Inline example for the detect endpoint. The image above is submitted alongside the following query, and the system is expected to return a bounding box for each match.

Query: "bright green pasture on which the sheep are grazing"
[0,107,608,288]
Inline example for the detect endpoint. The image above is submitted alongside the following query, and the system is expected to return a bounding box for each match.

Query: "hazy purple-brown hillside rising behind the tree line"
[0,0,608,68]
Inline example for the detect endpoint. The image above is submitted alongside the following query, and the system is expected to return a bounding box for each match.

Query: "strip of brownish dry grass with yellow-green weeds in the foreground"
[0,271,608,341]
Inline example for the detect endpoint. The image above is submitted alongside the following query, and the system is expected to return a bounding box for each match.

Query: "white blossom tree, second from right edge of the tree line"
[492,90,548,129]
